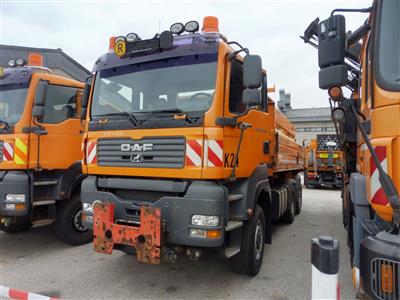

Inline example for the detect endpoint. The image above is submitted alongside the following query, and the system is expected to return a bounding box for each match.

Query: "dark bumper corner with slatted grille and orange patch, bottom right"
[360,231,400,299]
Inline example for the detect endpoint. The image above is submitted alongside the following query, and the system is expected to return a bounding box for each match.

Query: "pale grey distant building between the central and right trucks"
[278,89,336,144]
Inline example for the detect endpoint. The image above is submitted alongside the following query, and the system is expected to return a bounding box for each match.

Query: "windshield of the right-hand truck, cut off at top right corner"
[378,1,400,90]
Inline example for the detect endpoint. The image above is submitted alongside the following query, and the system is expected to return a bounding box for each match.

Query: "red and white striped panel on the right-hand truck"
[369,146,389,205]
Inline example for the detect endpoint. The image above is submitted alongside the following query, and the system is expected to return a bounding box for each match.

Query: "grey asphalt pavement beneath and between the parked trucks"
[0,189,355,300]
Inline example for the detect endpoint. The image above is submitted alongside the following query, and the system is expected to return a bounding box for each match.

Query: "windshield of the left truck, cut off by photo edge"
[0,83,28,125]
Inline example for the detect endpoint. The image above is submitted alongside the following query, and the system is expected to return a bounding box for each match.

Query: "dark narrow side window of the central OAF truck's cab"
[229,60,246,114]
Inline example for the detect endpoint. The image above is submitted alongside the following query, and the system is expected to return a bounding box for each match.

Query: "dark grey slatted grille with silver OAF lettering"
[97,137,186,168]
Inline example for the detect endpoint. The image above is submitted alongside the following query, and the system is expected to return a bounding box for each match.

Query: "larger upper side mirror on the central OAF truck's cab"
[243,54,262,89]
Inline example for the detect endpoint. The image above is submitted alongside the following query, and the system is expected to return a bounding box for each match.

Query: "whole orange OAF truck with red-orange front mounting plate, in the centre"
[82,17,304,275]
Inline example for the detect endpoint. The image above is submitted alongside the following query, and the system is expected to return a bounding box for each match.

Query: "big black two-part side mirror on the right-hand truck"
[318,15,348,89]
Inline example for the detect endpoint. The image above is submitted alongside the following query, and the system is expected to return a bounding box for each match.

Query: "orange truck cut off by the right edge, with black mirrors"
[304,0,400,299]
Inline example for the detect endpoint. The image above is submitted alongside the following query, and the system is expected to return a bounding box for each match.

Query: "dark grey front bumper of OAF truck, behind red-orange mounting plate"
[81,176,227,247]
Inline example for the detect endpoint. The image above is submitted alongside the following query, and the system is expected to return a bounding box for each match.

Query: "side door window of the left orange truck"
[38,84,78,124]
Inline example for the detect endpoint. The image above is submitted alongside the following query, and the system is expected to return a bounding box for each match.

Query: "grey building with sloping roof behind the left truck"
[0,45,91,81]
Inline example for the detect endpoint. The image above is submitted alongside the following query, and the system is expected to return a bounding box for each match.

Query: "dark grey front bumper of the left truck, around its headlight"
[0,171,30,217]
